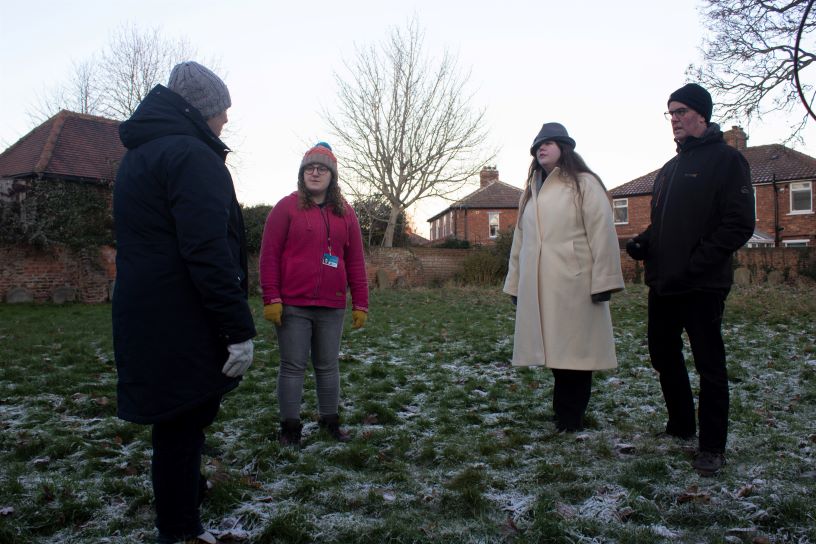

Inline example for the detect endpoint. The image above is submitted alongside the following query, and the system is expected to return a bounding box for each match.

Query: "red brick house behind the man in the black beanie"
[609,127,816,247]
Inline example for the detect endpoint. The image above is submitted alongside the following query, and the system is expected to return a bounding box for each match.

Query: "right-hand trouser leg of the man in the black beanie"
[685,293,729,453]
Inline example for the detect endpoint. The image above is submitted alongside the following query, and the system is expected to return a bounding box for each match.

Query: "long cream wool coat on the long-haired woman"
[504,168,623,370]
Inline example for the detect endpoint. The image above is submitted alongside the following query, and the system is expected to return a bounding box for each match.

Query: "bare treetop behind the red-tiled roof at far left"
[29,25,194,122]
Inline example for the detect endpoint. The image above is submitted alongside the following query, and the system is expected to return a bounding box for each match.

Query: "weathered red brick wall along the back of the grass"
[0,246,816,303]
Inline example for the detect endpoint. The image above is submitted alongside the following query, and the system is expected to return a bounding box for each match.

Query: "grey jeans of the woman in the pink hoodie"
[275,306,346,420]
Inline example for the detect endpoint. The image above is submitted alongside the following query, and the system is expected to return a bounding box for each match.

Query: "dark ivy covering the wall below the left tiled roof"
[0,179,114,250]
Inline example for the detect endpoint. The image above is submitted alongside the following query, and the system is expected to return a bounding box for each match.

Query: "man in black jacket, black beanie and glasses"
[626,83,754,476]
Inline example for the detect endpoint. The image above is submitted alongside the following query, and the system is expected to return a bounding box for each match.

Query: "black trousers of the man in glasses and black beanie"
[648,290,728,453]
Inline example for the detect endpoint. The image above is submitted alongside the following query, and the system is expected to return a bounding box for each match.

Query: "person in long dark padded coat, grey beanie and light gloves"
[113,62,255,543]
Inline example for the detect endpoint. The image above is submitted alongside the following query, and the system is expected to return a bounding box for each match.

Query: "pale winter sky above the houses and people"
[0,0,816,235]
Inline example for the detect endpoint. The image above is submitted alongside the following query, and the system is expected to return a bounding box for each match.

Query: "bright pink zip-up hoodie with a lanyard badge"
[260,192,368,312]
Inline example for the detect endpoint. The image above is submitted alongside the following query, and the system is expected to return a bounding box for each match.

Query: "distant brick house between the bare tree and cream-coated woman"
[428,166,521,244]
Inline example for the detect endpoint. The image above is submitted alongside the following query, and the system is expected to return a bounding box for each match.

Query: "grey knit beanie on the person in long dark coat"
[167,61,232,119]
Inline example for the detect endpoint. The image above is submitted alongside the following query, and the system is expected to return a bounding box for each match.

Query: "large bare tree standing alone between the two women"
[324,19,495,247]
